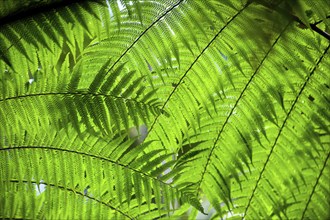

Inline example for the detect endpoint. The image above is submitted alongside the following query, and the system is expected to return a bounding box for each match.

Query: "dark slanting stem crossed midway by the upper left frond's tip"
[148,3,250,139]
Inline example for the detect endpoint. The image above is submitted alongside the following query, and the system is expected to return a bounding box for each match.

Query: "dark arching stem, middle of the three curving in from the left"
[0,146,174,188]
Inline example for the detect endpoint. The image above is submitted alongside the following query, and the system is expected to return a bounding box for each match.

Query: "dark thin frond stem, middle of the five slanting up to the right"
[198,19,291,193]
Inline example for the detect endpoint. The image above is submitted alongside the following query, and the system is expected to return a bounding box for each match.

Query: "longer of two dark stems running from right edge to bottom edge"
[243,44,330,217]
